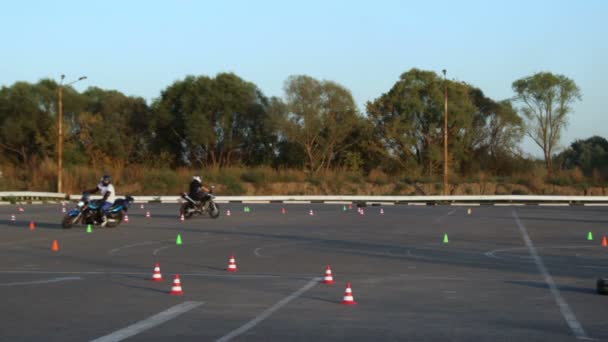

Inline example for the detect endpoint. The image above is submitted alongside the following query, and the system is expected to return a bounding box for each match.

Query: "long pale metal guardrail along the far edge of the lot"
[0,191,608,205]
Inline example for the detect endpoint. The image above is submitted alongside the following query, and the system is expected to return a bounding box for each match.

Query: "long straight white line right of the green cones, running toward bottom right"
[512,210,589,340]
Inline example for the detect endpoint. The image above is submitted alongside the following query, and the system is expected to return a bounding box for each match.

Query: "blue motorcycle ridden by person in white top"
[61,193,133,229]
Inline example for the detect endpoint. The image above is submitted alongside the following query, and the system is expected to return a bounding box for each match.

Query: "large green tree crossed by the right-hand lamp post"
[367,69,477,175]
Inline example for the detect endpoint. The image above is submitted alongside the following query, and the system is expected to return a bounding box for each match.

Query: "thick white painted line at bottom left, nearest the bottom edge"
[91,302,204,342]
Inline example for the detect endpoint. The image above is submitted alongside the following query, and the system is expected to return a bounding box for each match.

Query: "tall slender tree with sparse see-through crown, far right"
[512,72,581,174]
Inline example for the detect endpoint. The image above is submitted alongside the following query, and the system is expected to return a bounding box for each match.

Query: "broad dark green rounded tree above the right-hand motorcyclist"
[154,73,275,167]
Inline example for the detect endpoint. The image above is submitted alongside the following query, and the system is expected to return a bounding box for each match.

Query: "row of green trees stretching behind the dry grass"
[0,69,581,182]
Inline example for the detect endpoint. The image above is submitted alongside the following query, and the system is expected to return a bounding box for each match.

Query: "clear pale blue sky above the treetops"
[0,0,608,155]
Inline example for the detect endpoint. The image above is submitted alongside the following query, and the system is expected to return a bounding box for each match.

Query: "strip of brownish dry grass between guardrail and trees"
[0,159,606,195]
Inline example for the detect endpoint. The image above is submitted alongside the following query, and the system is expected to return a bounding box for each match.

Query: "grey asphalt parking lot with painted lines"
[0,204,608,341]
